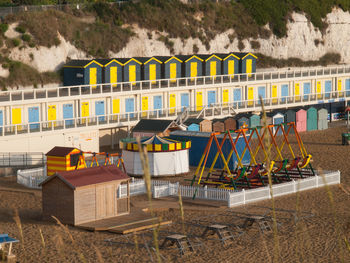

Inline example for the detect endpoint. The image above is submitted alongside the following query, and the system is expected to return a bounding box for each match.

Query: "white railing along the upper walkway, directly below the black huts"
[0,65,350,105]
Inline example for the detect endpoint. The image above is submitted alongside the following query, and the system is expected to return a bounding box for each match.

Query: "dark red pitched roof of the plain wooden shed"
[41,165,130,189]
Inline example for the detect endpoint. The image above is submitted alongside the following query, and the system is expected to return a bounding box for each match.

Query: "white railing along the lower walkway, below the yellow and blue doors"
[0,90,350,136]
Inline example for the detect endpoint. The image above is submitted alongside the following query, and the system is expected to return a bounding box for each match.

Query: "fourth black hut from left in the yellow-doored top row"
[138,57,163,83]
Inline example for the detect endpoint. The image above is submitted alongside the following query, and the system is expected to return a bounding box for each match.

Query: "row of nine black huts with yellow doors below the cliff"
[63,52,257,86]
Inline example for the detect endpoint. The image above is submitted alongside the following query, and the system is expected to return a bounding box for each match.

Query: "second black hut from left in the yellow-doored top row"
[96,58,125,87]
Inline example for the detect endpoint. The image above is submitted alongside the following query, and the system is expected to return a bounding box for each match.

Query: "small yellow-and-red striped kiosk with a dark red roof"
[46,146,85,176]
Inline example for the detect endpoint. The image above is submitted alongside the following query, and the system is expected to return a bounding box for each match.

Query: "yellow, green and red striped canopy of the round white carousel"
[120,135,191,152]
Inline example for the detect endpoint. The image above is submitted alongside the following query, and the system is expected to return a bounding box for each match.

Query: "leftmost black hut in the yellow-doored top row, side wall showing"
[63,60,103,87]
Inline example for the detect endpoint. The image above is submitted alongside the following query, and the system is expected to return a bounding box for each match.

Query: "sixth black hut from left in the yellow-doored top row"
[176,55,203,80]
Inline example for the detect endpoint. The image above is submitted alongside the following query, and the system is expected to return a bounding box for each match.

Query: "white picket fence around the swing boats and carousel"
[17,168,340,207]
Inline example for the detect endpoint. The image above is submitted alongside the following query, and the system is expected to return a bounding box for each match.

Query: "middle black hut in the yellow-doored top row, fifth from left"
[155,56,182,82]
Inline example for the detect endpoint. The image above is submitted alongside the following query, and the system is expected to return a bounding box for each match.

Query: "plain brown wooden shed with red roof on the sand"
[41,165,130,225]
